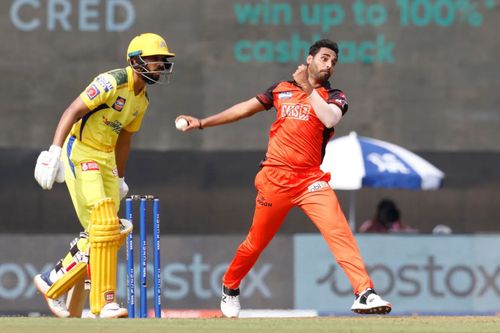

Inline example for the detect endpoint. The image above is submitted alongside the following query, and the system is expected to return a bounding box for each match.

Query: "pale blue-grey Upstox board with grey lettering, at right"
[294,235,500,314]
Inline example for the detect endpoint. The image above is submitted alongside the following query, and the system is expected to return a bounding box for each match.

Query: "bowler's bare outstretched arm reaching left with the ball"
[176,97,265,132]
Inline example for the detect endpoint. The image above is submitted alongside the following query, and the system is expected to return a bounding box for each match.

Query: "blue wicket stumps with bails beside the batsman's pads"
[125,195,161,318]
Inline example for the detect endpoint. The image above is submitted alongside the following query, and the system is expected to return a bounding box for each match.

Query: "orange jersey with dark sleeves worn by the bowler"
[256,81,348,169]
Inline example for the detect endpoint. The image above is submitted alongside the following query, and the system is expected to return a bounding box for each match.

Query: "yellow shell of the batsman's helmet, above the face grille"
[127,32,175,61]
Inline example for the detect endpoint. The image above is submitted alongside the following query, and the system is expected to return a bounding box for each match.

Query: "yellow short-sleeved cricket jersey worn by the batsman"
[70,67,149,152]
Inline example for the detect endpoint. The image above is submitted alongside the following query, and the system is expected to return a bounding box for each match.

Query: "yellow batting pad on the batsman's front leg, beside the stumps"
[89,198,121,315]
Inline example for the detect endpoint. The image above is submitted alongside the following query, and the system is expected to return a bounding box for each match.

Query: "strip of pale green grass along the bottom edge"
[0,316,500,333]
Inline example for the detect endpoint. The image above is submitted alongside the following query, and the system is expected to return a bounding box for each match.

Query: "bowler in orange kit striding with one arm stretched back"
[177,39,392,317]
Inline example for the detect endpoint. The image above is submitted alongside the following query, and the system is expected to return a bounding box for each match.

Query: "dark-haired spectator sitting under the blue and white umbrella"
[359,199,418,233]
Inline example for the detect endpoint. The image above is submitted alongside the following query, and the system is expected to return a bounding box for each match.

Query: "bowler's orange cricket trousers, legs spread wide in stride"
[222,166,373,293]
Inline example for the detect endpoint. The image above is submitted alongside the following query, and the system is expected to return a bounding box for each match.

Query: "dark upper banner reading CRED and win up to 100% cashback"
[0,0,500,151]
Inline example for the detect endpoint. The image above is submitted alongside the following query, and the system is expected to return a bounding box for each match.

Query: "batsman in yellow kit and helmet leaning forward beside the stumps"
[34,33,175,318]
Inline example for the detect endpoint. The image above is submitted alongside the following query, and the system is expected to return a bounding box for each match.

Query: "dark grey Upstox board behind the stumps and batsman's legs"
[0,235,293,314]
